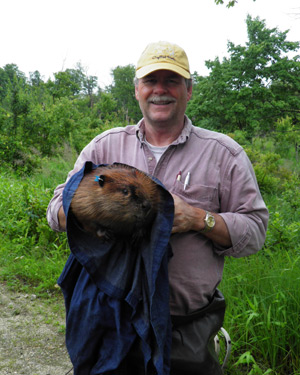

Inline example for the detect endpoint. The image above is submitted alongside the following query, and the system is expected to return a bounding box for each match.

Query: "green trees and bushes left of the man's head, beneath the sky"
[0,64,138,174]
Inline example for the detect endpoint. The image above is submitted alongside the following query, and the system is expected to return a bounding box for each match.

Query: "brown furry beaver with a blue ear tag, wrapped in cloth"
[70,163,161,242]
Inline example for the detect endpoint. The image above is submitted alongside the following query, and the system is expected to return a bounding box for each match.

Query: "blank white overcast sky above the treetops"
[0,0,300,87]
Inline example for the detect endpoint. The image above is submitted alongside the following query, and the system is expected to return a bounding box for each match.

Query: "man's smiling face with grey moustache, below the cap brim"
[135,70,192,126]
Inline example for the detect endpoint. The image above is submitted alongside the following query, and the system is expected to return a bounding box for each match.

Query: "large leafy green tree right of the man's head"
[188,16,300,132]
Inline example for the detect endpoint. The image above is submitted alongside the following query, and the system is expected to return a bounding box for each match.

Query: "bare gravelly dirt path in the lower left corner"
[0,284,73,375]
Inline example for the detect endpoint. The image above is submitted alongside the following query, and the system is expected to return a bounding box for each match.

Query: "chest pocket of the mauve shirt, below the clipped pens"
[171,181,220,212]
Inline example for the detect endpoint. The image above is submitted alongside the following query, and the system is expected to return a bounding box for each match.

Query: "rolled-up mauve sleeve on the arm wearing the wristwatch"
[216,151,269,258]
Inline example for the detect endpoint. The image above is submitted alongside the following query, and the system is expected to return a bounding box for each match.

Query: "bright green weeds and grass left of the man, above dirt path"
[0,160,71,294]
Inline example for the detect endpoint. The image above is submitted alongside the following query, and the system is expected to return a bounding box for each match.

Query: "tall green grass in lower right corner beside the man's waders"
[220,249,300,375]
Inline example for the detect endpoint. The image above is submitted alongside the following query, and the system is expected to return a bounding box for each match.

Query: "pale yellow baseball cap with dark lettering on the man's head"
[135,42,191,79]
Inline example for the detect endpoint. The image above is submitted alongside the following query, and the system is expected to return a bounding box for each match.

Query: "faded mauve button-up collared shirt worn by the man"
[47,117,269,315]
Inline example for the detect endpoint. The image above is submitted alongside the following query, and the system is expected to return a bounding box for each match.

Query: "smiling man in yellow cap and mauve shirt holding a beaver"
[47,42,268,375]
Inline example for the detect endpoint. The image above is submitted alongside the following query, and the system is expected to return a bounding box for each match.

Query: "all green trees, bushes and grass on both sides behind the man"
[0,17,300,375]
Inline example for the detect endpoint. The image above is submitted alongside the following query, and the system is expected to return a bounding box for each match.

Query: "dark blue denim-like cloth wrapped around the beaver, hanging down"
[58,162,174,375]
